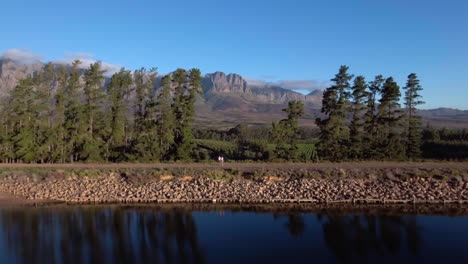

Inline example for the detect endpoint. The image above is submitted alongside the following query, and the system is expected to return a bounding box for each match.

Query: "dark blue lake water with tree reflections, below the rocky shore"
[0,206,468,264]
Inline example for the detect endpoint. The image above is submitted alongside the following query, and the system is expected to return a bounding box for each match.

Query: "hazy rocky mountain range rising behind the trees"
[0,59,468,128]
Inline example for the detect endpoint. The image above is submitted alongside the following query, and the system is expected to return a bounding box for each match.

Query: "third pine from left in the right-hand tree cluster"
[363,75,385,158]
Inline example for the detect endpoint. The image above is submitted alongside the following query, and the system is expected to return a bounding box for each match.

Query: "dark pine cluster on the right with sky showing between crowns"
[316,66,424,161]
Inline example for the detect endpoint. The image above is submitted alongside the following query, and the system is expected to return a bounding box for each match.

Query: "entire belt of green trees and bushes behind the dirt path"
[0,61,468,163]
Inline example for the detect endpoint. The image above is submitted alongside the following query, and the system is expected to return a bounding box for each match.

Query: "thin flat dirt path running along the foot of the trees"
[0,162,468,169]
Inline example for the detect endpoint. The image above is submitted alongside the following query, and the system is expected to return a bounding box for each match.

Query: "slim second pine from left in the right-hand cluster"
[349,76,368,159]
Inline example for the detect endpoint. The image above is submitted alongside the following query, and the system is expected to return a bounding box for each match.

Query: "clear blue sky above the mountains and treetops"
[0,0,468,109]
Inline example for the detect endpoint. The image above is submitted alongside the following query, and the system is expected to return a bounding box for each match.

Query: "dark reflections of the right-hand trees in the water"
[274,214,422,263]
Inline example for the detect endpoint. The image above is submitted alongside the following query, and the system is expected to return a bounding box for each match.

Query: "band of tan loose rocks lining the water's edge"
[0,167,468,204]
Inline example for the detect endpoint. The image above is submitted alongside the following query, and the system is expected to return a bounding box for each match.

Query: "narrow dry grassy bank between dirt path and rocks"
[0,163,468,184]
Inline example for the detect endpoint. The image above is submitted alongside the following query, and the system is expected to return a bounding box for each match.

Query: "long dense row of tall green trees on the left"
[0,60,202,163]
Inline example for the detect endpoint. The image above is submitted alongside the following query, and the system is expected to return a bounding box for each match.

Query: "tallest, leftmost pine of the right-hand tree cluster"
[316,66,353,161]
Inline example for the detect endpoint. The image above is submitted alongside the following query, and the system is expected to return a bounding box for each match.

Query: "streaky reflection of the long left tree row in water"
[0,207,204,264]
